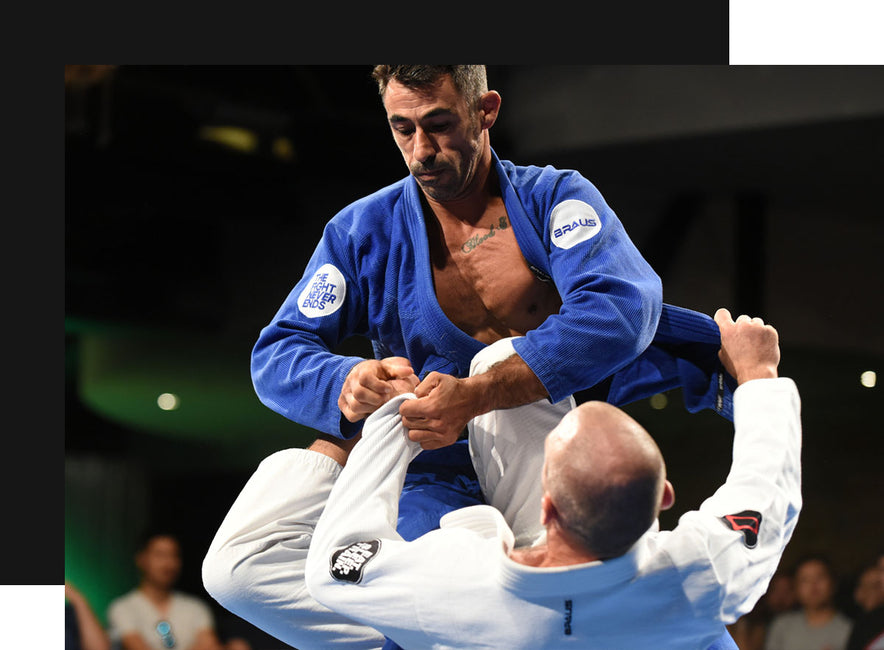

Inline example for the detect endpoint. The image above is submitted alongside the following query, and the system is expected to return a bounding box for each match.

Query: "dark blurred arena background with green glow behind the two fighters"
[64,65,884,647]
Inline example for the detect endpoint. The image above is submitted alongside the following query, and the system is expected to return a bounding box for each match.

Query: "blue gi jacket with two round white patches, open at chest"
[251,149,732,438]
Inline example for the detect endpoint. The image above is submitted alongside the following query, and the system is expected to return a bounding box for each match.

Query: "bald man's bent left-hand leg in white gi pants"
[202,449,384,650]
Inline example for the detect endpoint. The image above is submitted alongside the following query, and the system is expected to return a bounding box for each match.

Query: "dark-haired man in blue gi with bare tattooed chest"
[245,65,735,644]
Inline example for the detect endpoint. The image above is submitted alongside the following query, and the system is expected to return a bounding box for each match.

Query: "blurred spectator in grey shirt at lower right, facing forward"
[764,555,852,650]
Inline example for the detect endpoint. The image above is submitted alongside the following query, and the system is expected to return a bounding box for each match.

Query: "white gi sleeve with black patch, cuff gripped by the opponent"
[306,393,460,636]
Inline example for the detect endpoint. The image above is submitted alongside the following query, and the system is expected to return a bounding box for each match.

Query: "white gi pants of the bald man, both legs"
[202,339,574,650]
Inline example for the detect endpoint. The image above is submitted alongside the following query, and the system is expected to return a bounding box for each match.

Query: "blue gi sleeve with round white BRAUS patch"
[507,168,663,402]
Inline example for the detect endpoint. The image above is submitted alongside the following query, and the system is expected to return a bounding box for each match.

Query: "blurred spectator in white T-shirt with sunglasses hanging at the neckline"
[107,532,250,650]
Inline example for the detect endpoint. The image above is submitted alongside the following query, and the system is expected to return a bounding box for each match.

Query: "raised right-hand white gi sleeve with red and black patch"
[664,377,802,624]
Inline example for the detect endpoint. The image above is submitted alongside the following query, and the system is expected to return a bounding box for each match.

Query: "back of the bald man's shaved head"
[544,402,666,559]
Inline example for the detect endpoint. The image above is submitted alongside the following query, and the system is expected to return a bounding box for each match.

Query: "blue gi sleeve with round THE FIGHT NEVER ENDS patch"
[251,220,367,438]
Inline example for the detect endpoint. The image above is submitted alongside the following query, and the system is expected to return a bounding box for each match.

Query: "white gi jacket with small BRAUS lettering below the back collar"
[306,378,801,650]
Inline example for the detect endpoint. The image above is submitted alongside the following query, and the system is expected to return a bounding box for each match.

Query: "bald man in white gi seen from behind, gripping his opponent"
[203,309,801,650]
